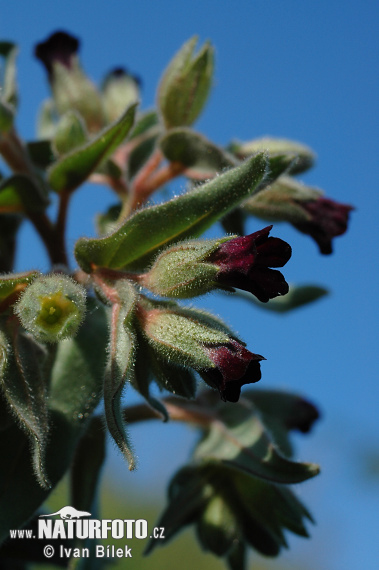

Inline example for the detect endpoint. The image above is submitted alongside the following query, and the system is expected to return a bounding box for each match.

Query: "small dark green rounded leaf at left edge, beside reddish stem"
[0,174,49,212]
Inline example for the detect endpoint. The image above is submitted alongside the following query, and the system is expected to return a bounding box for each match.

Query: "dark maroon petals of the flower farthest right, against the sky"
[294,197,354,254]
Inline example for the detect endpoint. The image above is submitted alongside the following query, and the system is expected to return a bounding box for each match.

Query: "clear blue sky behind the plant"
[0,0,379,570]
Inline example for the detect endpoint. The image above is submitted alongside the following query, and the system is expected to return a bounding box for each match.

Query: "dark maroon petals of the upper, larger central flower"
[207,226,292,303]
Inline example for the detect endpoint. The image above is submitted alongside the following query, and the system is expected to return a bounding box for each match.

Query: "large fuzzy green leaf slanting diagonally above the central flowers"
[75,154,266,272]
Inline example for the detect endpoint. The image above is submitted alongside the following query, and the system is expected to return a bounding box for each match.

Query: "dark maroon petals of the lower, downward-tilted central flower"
[201,340,265,402]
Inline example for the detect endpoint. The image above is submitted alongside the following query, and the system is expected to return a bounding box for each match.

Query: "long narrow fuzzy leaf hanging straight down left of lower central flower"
[104,280,137,470]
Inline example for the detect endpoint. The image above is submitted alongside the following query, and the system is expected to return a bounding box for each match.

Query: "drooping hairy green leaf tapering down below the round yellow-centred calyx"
[1,327,51,489]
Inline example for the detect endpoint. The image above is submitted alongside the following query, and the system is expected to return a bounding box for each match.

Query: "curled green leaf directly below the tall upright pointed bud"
[159,127,239,178]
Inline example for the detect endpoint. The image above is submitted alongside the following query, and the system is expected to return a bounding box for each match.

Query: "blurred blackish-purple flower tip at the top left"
[34,32,79,75]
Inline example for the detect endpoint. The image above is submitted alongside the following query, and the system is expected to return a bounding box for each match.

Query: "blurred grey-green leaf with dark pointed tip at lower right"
[194,404,319,483]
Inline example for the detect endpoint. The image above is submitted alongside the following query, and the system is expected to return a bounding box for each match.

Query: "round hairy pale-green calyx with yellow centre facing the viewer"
[15,275,86,342]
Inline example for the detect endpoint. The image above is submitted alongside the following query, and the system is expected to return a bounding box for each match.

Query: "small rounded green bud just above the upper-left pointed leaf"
[53,110,88,155]
